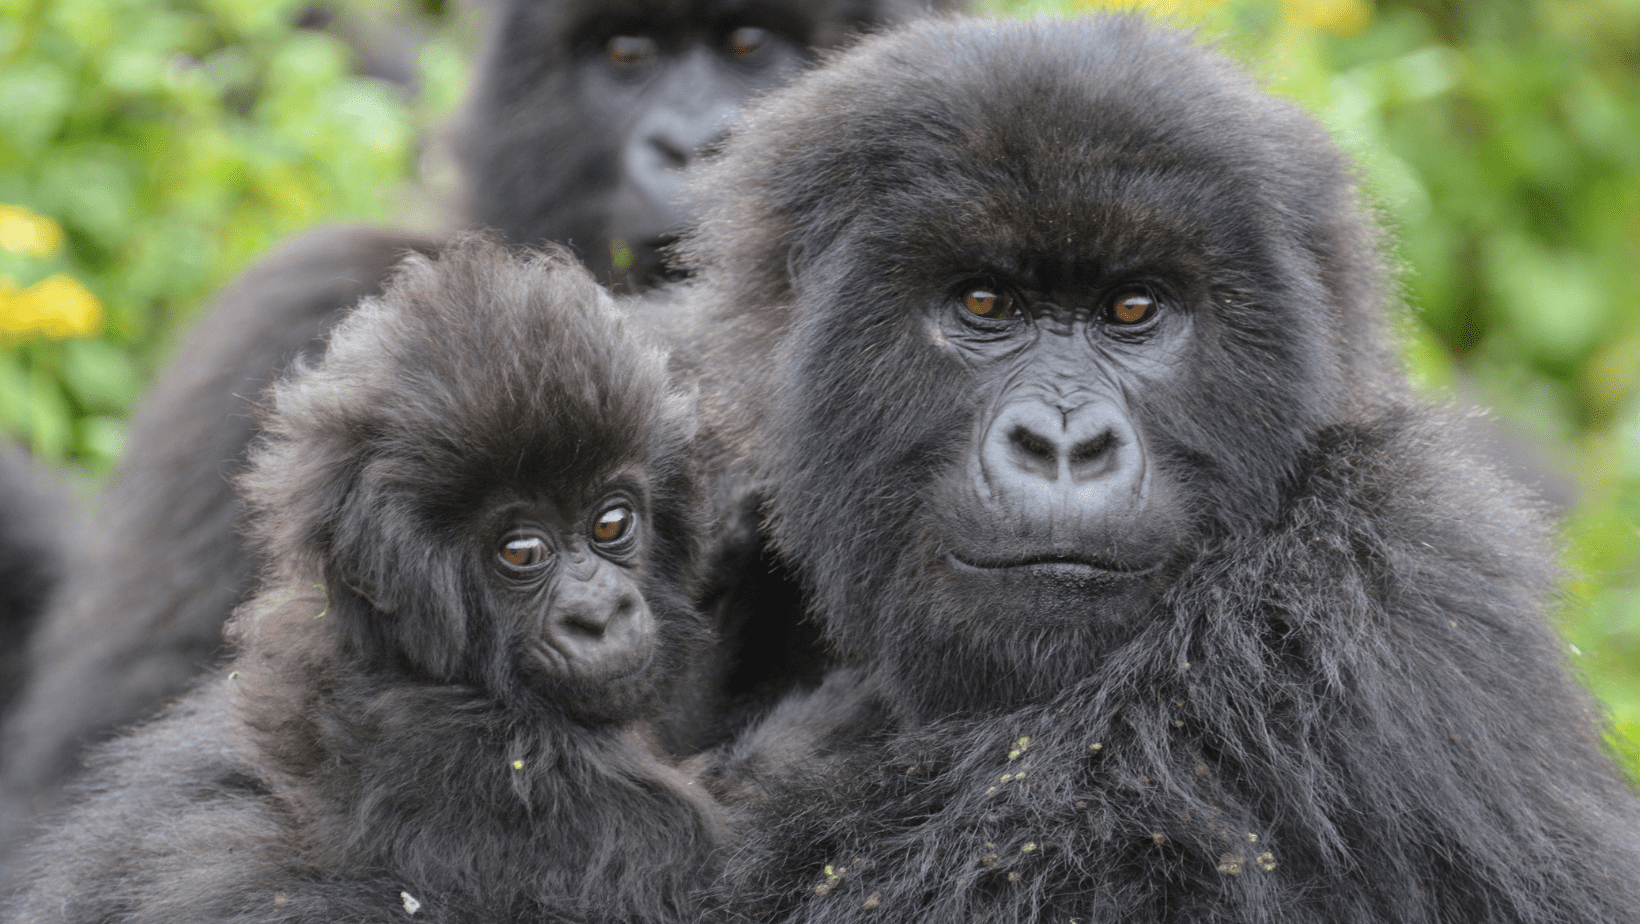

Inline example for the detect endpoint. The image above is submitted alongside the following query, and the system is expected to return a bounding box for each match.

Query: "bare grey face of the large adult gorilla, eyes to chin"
[922,272,1191,627]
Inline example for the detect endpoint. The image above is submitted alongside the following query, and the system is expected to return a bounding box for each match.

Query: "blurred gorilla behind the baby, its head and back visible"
[0,0,945,844]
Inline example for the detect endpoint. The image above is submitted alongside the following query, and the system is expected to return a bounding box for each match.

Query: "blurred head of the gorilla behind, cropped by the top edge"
[459,0,941,289]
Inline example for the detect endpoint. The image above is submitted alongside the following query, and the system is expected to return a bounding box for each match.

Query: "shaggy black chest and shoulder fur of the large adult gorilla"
[722,420,1640,924]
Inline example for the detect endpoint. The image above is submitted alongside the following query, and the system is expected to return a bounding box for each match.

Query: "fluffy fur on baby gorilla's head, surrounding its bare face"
[241,240,699,696]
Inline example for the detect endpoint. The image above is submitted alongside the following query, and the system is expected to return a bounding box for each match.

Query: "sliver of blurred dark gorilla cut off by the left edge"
[0,443,79,707]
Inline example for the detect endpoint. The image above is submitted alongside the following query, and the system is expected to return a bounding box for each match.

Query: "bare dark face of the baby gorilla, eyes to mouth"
[490,487,656,706]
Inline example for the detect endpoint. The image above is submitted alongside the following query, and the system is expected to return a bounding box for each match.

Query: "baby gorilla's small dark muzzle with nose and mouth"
[546,556,654,679]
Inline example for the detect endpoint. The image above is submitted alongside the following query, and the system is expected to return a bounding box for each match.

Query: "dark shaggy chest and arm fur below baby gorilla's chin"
[244,653,718,922]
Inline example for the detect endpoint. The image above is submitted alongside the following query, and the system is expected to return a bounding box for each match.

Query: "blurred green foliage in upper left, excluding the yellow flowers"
[0,0,461,471]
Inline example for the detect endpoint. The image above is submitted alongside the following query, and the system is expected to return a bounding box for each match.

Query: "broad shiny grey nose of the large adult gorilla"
[982,397,1143,515]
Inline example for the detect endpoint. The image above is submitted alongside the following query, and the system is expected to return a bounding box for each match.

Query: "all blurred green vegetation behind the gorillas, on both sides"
[0,0,1640,771]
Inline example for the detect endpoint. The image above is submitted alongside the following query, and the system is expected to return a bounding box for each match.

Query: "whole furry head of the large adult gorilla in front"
[692,18,1378,711]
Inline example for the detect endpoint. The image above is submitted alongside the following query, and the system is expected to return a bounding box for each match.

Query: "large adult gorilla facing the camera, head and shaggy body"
[662,18,1640,922]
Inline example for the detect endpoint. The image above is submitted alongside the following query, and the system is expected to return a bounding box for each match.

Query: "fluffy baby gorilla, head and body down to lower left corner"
[0,238,718,924]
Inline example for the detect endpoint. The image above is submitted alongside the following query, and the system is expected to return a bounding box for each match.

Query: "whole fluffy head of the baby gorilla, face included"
[243,238,707,724]
